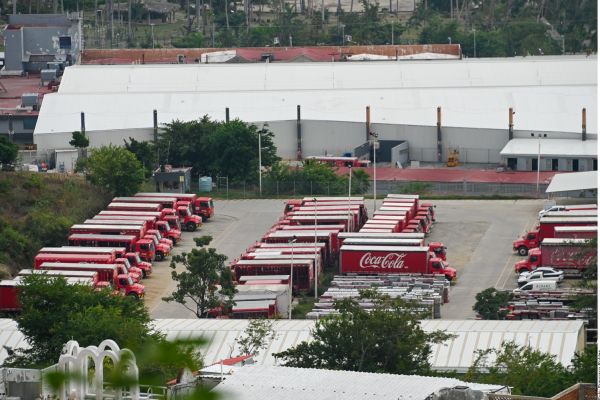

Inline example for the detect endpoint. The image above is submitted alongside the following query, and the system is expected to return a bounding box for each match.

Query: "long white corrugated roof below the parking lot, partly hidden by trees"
[0,319,585,372]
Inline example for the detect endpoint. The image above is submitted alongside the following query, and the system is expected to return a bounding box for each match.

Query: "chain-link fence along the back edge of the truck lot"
[198,177,548,199]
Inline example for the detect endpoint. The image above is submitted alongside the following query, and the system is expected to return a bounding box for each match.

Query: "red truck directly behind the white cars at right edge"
[515,238,598,276]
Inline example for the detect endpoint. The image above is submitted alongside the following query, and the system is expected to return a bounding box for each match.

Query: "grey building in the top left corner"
[2,13,83,75]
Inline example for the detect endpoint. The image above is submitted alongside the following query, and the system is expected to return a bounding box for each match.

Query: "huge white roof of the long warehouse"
[34,56,597,136]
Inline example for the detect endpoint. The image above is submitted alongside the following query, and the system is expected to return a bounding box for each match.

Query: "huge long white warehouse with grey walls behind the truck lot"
[34,56,597,170]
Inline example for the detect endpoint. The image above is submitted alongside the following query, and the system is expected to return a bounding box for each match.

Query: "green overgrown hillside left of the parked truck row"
[0,172,111,278]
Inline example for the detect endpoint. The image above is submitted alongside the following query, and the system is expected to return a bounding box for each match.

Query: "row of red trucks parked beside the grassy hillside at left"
[0,193,214,312]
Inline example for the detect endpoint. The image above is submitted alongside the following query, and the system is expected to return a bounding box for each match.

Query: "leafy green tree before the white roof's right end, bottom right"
[465,342,573,397]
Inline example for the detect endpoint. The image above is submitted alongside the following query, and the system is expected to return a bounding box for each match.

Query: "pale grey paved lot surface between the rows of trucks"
[144,200,543,319]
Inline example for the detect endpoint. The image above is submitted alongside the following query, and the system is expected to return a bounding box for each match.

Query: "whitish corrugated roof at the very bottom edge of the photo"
[213,365,508,400]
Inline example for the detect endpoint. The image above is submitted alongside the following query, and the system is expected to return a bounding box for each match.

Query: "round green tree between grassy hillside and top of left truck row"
[87,144,144,196]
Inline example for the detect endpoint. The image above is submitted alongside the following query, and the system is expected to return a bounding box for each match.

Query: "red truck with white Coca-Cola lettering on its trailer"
[340,245,456,281]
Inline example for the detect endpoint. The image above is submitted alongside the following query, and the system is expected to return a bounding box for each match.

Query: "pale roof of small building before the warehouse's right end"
[500,139,598,158]
